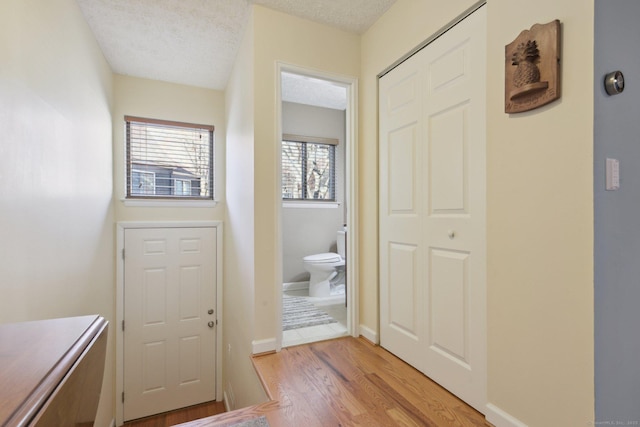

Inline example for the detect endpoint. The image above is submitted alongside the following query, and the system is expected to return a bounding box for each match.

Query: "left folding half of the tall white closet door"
[379,50,426,369]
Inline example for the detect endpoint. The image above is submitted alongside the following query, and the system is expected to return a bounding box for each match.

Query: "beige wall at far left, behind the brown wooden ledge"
[0,0,114,426]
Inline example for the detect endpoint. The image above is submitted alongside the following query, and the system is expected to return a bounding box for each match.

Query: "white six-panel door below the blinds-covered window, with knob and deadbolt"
[123,227,217,421]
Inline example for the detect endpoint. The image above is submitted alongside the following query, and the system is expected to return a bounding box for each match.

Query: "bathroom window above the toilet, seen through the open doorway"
[282,135,338,202]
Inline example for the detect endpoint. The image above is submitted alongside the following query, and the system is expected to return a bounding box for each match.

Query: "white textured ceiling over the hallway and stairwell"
[77,0,396,108]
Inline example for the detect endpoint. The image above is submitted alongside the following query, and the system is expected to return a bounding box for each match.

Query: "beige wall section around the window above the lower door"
[113,75,226,221]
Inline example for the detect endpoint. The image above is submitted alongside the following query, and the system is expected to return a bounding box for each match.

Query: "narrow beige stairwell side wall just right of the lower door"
[223,9,266,409]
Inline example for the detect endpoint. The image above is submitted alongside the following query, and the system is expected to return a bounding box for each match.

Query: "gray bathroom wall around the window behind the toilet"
[282,102,346,283]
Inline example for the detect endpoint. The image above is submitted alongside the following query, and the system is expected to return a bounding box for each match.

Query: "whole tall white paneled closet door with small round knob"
[380,7,486,412]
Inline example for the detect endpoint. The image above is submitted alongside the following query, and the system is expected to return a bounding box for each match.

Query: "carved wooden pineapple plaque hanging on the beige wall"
[504,19,560,113]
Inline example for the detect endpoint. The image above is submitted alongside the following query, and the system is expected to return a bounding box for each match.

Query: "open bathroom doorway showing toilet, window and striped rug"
[276,64,357,349]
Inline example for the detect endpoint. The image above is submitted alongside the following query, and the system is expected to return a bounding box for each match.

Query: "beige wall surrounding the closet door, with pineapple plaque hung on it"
[360,0,594,426]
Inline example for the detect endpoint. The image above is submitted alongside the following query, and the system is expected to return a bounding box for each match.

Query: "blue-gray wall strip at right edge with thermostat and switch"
[596,0,640,425]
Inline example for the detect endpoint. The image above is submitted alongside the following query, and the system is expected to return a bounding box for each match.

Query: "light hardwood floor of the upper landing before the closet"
[175,337,491,427]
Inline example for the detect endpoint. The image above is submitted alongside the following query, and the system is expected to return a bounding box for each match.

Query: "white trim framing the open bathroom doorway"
[274,61,360,351]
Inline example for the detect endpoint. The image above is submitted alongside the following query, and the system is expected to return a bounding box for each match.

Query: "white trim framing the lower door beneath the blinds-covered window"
[114,221,224,426]
